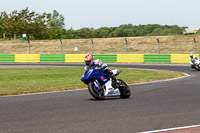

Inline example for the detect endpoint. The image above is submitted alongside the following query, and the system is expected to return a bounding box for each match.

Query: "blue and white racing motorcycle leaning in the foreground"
[81,66,131,100]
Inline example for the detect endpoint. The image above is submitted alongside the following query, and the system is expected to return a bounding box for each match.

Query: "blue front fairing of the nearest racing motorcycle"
[81,66,109,84]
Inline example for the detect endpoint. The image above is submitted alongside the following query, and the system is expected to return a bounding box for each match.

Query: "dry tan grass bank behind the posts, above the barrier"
[0,34,200,54]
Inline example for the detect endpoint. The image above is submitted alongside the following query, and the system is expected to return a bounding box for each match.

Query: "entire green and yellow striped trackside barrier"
[0,54,200,63]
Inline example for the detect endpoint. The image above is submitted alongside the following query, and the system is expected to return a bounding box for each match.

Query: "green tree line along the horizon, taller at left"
[0,8,194,40]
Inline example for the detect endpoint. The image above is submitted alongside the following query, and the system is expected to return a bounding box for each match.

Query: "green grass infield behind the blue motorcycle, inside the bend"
[0,67,184,96]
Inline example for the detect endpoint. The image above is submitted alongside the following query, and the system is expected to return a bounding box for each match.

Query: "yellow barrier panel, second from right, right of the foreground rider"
[117,54,144,63]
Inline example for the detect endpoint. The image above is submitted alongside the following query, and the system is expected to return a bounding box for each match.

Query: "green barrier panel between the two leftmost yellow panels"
[40,54,65,62]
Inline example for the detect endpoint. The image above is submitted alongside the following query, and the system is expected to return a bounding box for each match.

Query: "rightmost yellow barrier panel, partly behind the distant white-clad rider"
[171,54,199,63]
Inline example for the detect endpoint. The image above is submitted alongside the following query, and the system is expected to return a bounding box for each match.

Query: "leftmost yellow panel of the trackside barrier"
[15,54,40,62]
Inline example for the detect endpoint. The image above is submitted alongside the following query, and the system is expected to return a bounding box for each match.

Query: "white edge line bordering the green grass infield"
[0,68,190,98]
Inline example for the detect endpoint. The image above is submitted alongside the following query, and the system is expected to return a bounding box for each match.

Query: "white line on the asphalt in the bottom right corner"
[140,125,200,133]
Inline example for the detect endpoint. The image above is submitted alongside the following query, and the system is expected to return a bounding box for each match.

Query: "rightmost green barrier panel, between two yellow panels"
[144,54,171,63]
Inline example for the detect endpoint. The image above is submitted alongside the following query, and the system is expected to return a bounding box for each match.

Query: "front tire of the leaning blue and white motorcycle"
[88,82,105,100]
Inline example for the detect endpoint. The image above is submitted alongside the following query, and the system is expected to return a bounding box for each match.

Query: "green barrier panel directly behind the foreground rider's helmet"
[92,54,117,63]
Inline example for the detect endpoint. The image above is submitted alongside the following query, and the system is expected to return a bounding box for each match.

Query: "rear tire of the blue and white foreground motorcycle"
[117,79,131,98]
